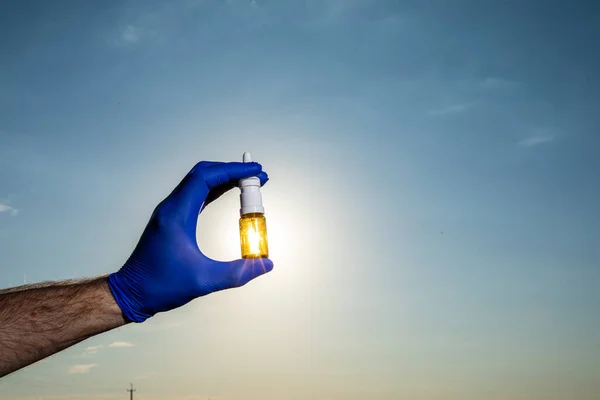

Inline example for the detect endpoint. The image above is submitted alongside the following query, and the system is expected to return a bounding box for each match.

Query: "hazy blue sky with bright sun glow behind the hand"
[0,0,600,400]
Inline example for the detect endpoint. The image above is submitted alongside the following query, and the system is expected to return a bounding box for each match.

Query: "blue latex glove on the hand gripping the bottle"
[108,161,273,322]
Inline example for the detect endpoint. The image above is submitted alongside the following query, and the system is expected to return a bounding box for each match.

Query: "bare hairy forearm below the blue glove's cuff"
[0,278,126,377]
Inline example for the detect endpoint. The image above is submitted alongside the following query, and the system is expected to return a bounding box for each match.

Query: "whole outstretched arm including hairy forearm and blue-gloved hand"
[0,161,273,376]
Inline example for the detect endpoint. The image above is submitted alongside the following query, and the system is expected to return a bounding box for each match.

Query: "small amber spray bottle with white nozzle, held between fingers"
[239,152,269,258]
